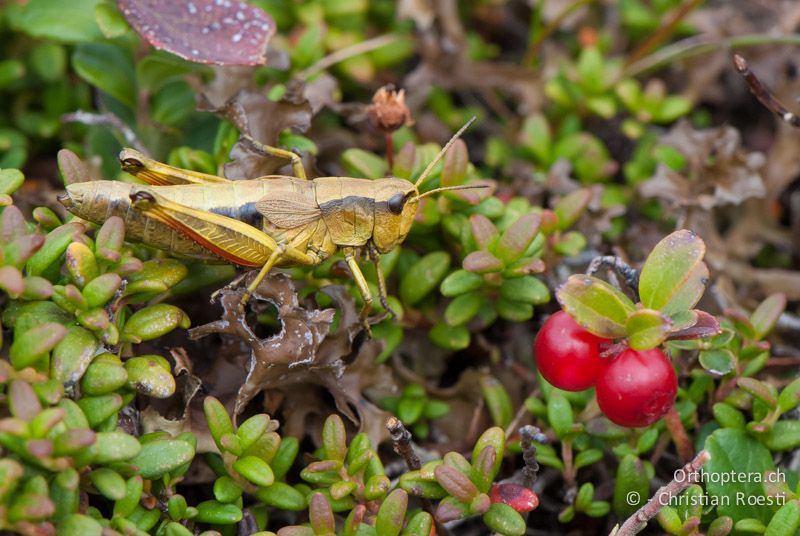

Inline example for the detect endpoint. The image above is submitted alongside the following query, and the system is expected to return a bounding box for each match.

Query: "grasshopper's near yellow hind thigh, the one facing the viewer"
[130,188,278,267]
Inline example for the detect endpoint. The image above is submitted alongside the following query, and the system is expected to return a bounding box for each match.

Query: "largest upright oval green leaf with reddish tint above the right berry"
[639,229,709,315]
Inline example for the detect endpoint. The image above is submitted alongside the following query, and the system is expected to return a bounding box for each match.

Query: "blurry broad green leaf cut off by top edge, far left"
[19,0,103,43]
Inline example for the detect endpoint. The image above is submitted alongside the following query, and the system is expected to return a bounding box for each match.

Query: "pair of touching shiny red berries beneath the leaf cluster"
[534,311,678,428]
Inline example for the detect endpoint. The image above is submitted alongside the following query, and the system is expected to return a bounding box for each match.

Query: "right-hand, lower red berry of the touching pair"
[595,348,678,428]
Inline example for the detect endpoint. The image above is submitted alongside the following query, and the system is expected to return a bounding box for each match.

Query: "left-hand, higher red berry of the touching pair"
[533,311,608,391]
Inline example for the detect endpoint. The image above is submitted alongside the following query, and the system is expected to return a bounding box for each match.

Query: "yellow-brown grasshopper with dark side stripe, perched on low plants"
[58,118,485,328]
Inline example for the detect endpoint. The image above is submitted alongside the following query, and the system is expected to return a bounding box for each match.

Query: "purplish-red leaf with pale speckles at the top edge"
[117,0,275,65]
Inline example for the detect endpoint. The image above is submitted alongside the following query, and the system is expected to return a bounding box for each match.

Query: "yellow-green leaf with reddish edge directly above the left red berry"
[556,275,636,339]
